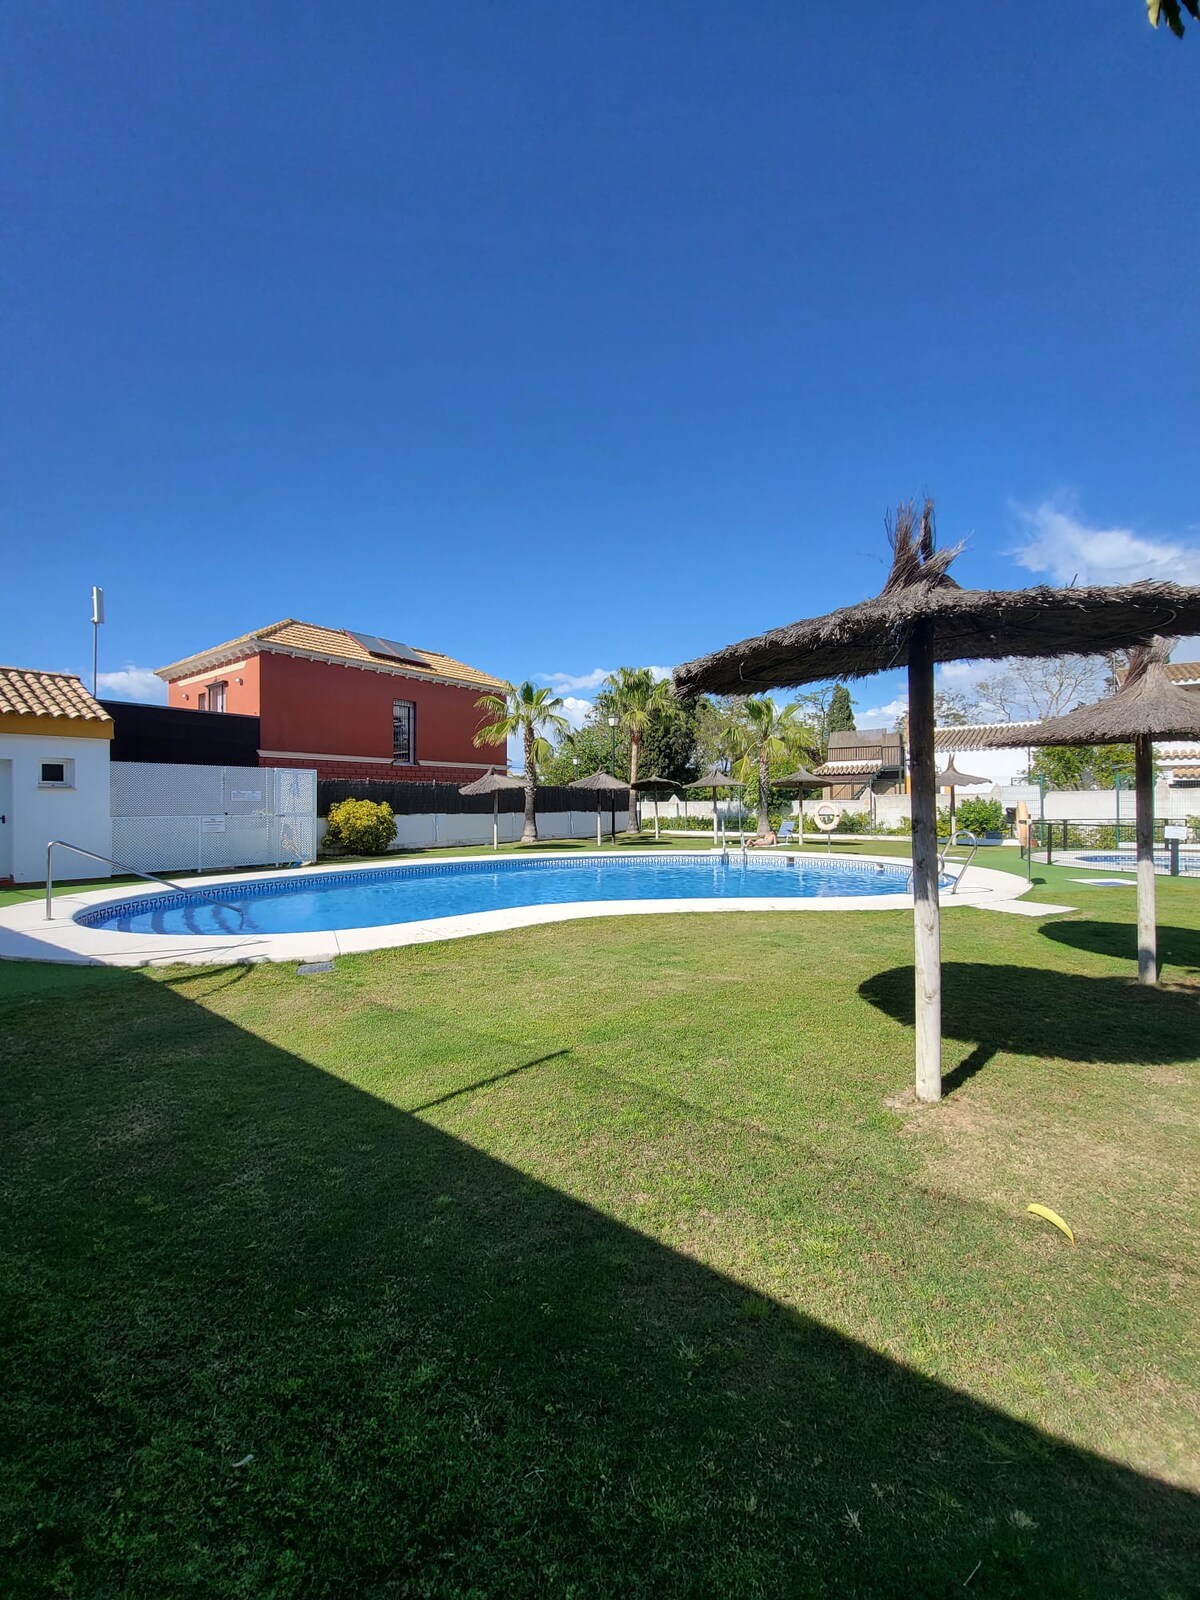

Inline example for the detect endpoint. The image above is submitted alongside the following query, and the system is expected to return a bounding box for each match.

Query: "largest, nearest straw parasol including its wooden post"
[675,501,1200,1101]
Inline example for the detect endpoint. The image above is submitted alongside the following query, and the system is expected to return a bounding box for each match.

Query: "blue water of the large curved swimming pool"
[75,853,909,934]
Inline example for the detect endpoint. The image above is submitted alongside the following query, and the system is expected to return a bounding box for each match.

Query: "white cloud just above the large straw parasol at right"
[1011,496,1200,584]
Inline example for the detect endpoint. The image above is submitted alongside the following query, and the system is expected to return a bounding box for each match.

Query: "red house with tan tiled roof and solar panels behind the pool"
[158,619,507,782]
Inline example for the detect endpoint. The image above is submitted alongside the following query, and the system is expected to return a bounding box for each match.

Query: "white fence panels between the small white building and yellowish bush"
[110,762,317,872]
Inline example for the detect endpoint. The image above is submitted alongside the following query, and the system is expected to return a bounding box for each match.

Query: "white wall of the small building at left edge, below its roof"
[0,733,112,883]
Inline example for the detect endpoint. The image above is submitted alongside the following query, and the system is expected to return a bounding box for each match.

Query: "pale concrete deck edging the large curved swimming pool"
[0,850,1049,966]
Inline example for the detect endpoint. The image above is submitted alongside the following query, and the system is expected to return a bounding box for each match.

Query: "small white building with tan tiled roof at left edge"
[0,667,112,883]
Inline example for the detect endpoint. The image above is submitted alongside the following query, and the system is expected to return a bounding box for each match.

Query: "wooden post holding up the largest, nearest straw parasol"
[909,621,942,1101]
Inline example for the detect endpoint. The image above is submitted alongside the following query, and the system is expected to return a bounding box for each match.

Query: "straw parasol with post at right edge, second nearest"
[990,638,1200,984]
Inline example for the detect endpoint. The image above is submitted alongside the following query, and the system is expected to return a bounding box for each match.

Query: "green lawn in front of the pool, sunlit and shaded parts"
[0,842,1200,1600]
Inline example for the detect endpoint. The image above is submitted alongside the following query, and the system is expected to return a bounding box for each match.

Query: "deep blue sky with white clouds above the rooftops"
[0,0,1200,729]
